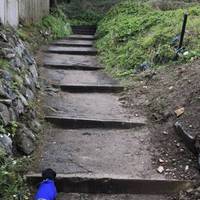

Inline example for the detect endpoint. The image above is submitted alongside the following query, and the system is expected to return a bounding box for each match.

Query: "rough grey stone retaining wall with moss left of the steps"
[0,27,40,155]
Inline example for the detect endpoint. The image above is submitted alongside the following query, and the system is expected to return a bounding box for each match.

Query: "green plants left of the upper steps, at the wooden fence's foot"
[17,9,71,51]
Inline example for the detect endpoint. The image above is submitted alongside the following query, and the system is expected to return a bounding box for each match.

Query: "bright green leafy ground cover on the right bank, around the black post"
[97,0,200,76]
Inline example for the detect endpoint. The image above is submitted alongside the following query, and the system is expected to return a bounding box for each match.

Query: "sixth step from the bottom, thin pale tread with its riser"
[52,39,93,47]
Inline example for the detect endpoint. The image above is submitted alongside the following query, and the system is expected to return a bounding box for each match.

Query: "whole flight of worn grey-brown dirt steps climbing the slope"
[27,26,191,200]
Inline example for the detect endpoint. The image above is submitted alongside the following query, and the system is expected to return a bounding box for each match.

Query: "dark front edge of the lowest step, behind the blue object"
[26,174,192,195]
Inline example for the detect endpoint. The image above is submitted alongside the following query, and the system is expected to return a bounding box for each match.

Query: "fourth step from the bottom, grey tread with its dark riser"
[43,53,103,70]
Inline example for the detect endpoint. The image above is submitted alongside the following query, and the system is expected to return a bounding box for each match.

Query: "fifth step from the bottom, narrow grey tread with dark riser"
[45,45,97,56]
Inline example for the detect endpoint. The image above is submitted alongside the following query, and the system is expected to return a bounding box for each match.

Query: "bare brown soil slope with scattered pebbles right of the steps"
[121,60,200,179]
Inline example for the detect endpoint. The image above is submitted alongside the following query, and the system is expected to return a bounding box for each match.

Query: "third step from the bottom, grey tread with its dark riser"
[41,68,124,93]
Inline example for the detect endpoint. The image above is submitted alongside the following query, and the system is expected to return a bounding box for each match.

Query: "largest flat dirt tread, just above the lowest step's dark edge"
[27,128,164,179]
